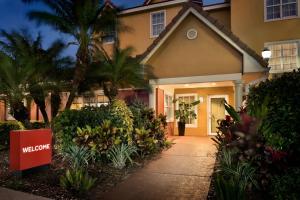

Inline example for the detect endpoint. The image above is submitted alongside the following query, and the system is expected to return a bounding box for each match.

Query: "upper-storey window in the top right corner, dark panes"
[265,0,298,20]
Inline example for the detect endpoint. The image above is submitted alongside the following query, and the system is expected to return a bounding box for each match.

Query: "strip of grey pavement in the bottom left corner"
[0,187,50,200]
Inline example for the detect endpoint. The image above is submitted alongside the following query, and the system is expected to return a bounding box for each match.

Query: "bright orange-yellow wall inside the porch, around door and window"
[174,87,234,136]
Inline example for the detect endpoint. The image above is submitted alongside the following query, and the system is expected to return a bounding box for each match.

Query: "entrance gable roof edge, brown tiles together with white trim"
[138,2,268,68]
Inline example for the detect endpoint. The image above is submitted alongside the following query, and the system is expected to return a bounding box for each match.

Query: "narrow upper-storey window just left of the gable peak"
[151,11,166,37]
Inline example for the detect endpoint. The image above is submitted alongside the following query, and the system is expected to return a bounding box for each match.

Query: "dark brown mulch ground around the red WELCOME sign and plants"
[0,150,158,200]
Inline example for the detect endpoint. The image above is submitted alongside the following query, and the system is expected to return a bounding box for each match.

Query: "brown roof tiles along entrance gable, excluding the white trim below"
[138,2,268,67]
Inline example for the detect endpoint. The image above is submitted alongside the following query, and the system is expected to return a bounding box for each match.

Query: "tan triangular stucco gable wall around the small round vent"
[147,14,242,78]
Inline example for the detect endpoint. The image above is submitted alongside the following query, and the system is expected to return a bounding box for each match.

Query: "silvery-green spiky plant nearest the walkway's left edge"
[107,143,137,169]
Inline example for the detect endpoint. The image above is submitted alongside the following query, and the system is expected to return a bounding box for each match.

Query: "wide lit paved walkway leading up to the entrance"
[101,137,216,200]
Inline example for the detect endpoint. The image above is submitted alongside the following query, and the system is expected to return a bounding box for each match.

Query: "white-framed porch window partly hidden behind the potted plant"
[176,94,198,127]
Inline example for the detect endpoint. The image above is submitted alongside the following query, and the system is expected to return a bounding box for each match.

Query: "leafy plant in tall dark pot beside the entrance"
[174,99,200,136]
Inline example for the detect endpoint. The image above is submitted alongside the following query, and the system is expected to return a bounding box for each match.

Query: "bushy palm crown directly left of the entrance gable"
[88,46,153,102]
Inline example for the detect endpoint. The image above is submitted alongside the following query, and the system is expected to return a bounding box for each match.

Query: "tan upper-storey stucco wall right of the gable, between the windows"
[231,0,300,54]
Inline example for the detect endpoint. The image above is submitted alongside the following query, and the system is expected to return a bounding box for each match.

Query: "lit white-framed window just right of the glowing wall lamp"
[268,42,299,73]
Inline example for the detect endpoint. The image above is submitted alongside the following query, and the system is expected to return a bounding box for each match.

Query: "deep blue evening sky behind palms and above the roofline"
[0,0,222,55]
